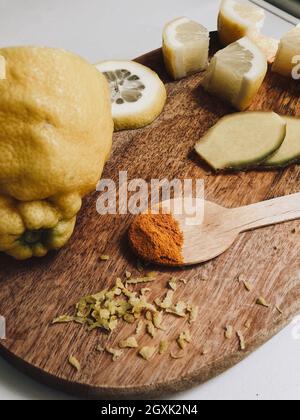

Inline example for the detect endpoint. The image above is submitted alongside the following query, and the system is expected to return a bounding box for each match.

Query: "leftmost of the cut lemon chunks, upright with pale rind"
[163,17,209,80]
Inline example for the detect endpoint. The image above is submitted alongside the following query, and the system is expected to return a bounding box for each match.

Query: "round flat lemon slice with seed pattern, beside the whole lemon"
[96,61,167,131]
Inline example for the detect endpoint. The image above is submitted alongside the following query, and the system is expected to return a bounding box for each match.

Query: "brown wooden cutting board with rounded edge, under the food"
[0,34,300,398]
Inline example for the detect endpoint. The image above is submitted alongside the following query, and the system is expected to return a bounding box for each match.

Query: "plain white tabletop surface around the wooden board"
[0,0,300,400]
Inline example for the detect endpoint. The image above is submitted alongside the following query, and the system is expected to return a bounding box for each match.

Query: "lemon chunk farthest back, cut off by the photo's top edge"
[218,0,265,45]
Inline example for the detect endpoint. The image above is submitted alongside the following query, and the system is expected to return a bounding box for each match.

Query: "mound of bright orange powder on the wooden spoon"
[129,214,184,265]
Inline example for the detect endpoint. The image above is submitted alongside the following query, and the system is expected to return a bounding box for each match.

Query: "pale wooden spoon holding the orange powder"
[162,193,300,265]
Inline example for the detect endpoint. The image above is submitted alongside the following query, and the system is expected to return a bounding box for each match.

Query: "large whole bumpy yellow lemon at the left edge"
[0,47,113,259]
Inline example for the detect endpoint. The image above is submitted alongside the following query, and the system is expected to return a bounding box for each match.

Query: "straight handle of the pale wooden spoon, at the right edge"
[233,193,300,232]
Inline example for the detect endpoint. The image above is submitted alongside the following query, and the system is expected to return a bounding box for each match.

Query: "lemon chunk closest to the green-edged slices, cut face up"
[202,37,268,111]
